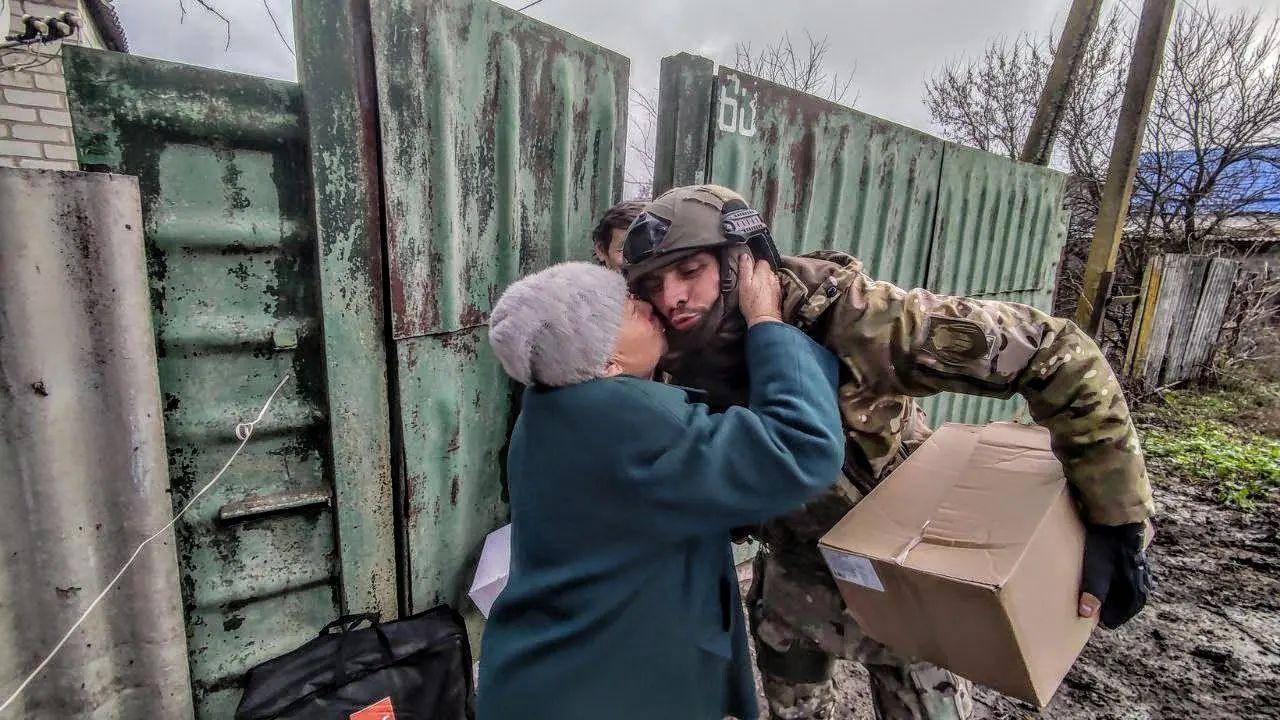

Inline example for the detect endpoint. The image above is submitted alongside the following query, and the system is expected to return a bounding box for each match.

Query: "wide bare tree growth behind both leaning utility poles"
[924,5,1280,347]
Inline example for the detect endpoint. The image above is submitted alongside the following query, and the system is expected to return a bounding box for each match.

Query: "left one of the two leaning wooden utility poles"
[1023,0,1102,165]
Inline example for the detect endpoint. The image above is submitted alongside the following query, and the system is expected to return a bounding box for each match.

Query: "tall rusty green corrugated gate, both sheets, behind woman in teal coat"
[372,0,628,622]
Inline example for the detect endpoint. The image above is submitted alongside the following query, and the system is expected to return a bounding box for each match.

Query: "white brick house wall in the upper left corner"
[0,0,102,170]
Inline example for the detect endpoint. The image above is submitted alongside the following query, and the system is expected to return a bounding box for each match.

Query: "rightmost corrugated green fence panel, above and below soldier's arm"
[922,143,1066,427]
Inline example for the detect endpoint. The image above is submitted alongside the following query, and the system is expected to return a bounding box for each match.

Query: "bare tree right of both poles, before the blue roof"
[1135,8,1280,254]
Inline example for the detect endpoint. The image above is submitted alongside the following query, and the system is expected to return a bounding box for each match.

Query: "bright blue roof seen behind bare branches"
[1133,145,1280,214]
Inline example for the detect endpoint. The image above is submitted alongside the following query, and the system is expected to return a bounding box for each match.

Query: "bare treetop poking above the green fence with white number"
[733,31,858,104]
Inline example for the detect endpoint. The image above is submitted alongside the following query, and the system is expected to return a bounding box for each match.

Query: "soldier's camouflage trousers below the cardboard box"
[746,548,973,720]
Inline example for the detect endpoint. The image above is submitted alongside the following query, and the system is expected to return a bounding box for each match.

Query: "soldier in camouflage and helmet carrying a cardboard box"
[623,186,1153,720]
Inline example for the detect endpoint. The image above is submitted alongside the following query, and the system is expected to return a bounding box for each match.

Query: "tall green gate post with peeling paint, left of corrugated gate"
[297,3,399,619]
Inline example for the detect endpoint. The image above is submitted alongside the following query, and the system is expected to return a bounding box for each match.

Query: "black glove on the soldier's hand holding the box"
[1080,523,1152,629]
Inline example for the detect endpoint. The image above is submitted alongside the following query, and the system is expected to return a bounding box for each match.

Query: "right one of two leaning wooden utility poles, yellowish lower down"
[1075,0,1175,337]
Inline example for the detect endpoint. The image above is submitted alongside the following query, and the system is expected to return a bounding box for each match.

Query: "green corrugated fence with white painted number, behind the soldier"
[654,54,1066,423]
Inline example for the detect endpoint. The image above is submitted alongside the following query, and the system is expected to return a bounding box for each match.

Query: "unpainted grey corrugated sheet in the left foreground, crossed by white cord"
[0,169,192,719]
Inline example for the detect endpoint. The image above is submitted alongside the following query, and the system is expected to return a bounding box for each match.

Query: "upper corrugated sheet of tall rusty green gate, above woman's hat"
[372,0,628,338]
